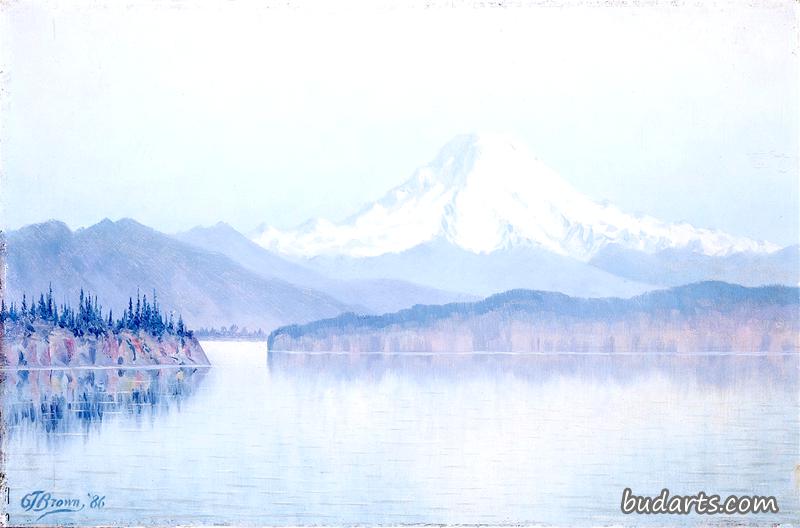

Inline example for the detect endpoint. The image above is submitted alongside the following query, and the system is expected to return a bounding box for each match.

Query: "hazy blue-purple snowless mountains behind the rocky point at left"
[4,219,472,331]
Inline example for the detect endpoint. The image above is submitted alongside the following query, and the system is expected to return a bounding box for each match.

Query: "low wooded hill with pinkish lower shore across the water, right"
[268,282,800,353]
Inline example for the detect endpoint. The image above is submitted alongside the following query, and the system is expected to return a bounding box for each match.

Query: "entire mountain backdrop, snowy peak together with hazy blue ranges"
[5,135,800,331]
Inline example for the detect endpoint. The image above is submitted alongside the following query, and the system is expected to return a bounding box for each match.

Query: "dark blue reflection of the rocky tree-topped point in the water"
[0,367,207,435]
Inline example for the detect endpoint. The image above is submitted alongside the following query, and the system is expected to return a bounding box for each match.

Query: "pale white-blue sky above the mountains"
[0,0,800,245]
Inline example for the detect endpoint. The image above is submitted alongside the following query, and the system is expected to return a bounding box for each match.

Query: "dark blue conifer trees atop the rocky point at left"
[0,286,193,337]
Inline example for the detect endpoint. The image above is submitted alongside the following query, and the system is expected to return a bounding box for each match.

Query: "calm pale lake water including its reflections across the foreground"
[2,342,800,526]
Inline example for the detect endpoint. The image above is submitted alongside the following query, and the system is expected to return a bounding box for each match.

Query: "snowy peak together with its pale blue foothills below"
[253,135,800,296]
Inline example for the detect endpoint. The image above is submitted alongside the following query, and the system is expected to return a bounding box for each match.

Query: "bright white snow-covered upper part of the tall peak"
[254,135,780,262]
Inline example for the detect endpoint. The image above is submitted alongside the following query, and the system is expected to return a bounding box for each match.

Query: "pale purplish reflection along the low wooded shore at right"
[267,352,800,391]
